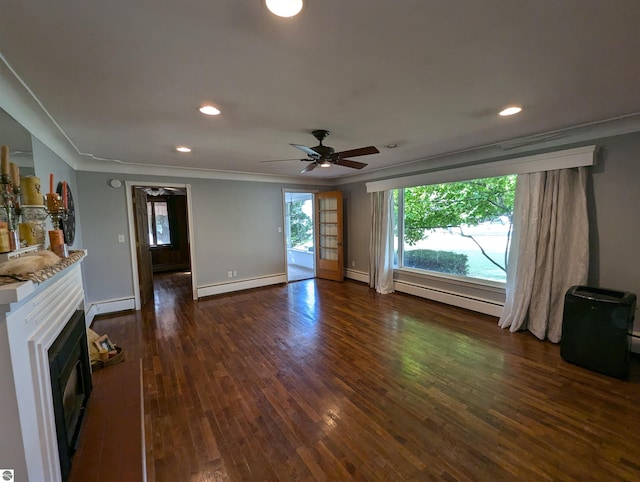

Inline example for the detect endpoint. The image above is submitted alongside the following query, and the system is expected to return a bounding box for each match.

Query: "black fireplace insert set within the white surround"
[49,310,92,480]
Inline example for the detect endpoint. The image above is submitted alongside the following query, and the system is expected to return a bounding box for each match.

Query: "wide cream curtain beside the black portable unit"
[498,167,589,343]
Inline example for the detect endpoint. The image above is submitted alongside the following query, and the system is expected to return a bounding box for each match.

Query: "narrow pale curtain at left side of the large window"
[369,191,393,295]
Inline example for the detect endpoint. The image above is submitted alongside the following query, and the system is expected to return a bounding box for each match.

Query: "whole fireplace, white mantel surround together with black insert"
[0,254,86,482]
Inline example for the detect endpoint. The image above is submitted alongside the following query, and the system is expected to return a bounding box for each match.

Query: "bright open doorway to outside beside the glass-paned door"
[284,191,315,282]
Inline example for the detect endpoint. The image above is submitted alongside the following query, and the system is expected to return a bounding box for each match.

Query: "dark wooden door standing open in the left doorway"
[133,187,153,306]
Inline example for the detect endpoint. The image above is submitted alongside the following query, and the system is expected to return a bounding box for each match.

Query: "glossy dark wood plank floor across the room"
[73,275,640,482]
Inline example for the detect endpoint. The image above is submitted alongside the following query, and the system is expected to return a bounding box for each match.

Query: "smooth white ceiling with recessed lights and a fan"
[0,0,640,178]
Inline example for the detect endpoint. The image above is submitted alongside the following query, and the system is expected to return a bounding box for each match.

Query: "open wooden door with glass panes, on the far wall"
[315,191,344,281]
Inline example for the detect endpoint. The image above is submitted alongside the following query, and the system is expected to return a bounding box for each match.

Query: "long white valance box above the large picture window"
[366,145,597,193]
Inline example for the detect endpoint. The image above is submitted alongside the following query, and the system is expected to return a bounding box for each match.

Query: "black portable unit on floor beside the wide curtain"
[560,286,636,378]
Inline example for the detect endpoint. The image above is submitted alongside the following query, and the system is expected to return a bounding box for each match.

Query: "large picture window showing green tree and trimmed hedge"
[394,175,516,282]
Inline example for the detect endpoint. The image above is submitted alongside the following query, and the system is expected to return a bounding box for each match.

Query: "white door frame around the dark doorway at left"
[124,181,198,311]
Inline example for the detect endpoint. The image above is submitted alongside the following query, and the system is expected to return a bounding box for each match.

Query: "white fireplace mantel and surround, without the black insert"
[0,254,84,482]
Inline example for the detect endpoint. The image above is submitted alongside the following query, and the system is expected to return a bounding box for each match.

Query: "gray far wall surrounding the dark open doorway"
[77,171,326,303]
